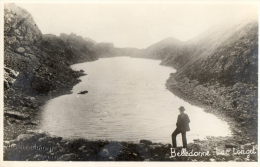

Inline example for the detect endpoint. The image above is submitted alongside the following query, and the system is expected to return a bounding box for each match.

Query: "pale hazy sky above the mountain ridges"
[17,3,257,48]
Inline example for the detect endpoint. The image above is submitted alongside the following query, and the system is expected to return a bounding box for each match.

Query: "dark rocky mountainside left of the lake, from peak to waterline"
[4,4,114,138]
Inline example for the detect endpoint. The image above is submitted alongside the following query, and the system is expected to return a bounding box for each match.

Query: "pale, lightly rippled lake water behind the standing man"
[41,57,230,144]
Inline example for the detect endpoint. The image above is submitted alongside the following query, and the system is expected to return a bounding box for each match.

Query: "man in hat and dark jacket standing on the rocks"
[172,106,190,148]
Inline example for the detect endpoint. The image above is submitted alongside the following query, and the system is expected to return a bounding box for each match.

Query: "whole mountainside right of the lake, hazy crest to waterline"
[142,21,258,141]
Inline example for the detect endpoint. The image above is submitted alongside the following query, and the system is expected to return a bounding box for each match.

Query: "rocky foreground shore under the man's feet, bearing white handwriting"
[4,130,257,162]
